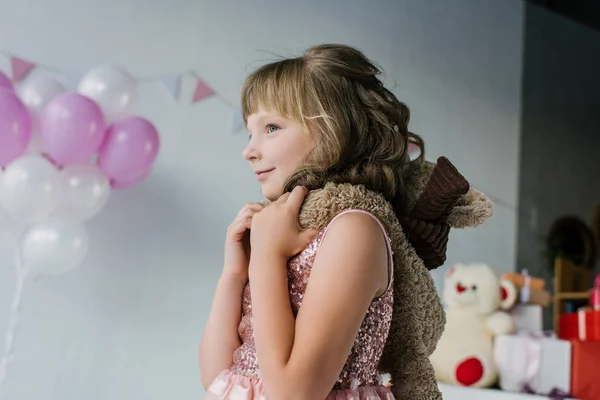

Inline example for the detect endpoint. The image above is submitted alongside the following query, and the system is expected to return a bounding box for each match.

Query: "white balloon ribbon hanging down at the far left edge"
[0,238,27,395]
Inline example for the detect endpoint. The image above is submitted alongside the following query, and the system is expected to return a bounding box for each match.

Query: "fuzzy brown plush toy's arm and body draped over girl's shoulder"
[300,183,445,400]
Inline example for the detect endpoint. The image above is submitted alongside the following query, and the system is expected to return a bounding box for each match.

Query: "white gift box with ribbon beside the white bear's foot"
[494,334,571,396]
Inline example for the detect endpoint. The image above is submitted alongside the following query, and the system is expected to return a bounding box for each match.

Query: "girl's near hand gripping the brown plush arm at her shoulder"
[250,186,316,261]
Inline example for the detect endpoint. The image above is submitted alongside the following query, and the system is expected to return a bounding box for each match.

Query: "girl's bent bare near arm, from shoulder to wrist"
[250,213,388,400]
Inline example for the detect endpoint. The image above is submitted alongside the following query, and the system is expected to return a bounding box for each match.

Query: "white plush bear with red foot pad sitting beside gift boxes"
[430,264,517,387]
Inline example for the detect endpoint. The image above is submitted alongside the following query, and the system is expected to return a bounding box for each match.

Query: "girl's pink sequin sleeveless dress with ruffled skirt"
[205,210,394,400]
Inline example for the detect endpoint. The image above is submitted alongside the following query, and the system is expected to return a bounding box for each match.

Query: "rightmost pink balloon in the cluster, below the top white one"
[98,117,160,182]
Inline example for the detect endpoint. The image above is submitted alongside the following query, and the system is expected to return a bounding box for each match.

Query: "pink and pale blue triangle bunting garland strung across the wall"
[0,50,244,133]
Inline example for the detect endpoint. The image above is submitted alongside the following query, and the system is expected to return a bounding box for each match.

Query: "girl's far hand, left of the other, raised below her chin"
[224,203,264,282]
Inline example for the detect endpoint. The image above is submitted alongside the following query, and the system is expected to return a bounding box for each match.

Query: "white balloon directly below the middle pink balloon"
[56,164,110,222]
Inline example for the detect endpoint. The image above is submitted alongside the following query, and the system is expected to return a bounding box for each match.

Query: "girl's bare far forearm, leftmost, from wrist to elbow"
[198,272,246,389]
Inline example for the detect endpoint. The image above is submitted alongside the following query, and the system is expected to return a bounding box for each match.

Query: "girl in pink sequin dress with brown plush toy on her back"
[199,45,490,400]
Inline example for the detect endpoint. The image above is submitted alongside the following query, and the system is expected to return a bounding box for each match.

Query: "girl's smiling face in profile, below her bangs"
[243,109,314,201]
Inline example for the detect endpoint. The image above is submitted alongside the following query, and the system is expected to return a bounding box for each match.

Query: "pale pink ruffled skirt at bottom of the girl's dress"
[204,370,395,400]
